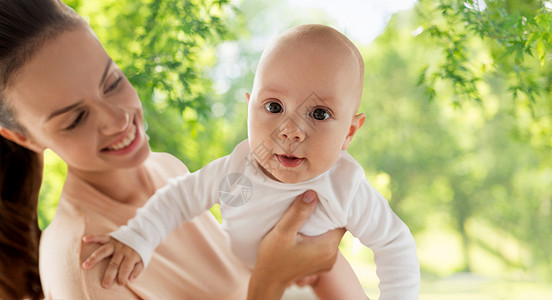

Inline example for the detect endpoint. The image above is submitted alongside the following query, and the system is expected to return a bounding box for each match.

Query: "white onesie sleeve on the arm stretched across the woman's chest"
[110,158,224,267]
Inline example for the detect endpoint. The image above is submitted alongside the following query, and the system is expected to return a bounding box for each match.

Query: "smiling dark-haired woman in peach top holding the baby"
[0,0,343,299]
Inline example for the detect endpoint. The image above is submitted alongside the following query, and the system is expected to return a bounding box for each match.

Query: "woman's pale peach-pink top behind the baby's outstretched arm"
[36,153,249,300]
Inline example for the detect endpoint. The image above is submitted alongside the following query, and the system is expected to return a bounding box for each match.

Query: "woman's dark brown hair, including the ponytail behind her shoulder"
[0,0,86,299]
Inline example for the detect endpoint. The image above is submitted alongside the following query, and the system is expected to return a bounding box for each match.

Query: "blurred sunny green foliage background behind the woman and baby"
[39,0,552,299]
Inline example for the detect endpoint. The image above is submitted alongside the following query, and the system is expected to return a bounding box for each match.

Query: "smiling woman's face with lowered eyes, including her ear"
[6,28,150,172]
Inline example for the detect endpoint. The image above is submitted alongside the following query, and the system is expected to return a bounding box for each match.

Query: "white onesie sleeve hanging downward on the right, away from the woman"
[347,180,420,300]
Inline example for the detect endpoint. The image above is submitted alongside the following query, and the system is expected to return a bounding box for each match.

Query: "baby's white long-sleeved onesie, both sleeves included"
[111,140,420,300]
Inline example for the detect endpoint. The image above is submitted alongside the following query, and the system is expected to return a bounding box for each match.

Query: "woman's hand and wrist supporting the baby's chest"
[247,191,345,300]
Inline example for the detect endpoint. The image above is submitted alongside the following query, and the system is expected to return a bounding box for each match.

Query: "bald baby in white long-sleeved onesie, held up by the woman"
[84,25,420,300]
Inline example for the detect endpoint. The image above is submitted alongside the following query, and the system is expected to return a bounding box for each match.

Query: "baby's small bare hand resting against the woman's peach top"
[82,235,144,289]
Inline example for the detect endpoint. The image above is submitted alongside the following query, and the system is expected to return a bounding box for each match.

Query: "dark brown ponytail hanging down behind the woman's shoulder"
[0,139,42,299]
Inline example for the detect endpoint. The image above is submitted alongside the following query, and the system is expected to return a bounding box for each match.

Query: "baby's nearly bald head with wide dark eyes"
[247,25,365,183]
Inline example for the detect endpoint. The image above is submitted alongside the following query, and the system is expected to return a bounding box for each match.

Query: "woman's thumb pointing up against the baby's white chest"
[275,190,318,233]
